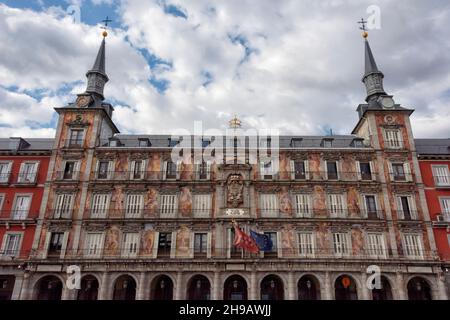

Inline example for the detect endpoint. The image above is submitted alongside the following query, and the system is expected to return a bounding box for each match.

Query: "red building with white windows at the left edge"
[0,138,53,300]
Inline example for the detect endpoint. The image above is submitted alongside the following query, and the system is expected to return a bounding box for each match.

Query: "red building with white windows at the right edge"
[415,139,450,296]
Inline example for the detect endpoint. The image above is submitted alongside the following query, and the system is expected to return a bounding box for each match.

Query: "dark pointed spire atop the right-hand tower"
[358,19,386,102]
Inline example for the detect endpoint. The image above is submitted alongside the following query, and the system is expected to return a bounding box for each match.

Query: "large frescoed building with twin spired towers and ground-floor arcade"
[1,31,447,300]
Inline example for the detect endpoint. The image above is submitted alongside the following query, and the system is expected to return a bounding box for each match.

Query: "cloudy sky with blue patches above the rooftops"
[0,0,450,138]
